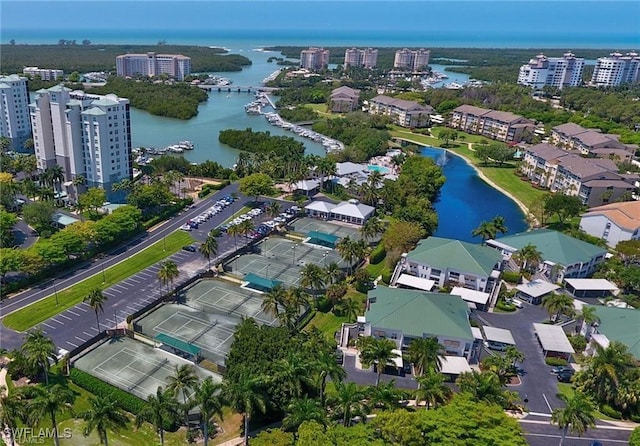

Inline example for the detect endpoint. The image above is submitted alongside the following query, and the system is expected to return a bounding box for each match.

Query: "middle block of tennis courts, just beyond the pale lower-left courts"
[136,280,277,365]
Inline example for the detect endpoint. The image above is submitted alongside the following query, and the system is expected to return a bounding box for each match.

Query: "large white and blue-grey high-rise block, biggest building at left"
[29,85,133,197]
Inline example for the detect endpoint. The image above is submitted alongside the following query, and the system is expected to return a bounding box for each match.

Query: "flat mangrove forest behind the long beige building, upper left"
[0,41,251,73]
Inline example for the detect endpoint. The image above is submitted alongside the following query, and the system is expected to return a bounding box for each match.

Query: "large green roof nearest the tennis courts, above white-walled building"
[365,287,474,341]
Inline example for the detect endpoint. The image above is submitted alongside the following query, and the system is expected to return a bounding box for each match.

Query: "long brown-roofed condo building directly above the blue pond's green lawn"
[451,105,535,142]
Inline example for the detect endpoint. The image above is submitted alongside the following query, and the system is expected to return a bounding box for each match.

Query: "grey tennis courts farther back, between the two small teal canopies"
[225,237,347,288]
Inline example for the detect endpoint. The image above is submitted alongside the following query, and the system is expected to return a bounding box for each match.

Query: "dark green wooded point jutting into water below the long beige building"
[91,77,208,119]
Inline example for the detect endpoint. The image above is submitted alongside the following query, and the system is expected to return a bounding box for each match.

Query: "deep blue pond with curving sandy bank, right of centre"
[422,146,527,243]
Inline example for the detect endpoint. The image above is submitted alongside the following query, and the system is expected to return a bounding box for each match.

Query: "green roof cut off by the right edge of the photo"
[594,306,640,360]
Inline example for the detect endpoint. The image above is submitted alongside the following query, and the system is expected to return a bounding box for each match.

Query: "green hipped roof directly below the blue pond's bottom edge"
[407,237,502,276]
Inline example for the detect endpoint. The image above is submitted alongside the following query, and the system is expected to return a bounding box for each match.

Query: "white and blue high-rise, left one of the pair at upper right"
[518,53,584,89]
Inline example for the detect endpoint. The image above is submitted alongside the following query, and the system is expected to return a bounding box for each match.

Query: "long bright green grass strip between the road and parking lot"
[2,231,193,331]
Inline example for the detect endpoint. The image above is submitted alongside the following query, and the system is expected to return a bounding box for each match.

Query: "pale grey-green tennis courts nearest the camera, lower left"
[74,337,222,400]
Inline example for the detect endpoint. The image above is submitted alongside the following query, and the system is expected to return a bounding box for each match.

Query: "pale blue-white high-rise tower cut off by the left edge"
[0,74,31,151]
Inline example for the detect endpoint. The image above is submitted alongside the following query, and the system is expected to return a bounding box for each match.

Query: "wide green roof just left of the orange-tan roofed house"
[496,229,607,265]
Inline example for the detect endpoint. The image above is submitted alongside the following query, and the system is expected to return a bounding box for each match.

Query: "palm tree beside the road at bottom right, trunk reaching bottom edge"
[551,392,596,446]
